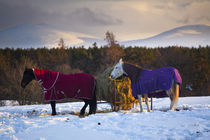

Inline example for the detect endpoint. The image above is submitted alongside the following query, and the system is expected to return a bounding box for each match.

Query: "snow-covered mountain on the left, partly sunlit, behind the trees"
[0,24,105,48]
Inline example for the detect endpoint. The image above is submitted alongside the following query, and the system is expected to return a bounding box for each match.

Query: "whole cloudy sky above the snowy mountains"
[0,0,210,41]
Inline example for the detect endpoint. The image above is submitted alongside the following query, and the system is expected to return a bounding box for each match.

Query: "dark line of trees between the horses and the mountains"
[0,32,210,104]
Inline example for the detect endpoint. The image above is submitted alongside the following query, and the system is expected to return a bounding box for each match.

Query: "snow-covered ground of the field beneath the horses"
[0,97,210,140]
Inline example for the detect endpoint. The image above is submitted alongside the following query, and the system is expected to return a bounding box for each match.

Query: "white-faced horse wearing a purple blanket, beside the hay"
[110,59,182,112]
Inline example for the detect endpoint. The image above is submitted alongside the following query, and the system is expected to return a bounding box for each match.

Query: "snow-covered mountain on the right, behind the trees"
[120,25,210,47]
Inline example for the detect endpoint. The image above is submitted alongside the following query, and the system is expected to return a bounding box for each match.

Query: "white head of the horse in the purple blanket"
[111,58,126,79]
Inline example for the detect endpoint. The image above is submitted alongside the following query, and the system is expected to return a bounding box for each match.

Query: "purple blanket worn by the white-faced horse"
[131,67,182,98]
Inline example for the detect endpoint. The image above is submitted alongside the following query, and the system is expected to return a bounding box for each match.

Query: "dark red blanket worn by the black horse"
[34,69,95,101]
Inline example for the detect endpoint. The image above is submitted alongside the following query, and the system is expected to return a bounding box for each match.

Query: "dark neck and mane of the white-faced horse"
[123,62,144,82]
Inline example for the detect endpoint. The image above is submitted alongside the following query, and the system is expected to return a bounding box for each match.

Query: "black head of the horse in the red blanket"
[21,68,35,88]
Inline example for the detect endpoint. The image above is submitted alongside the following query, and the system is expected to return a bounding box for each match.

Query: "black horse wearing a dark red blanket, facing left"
[21,68,97,117]
